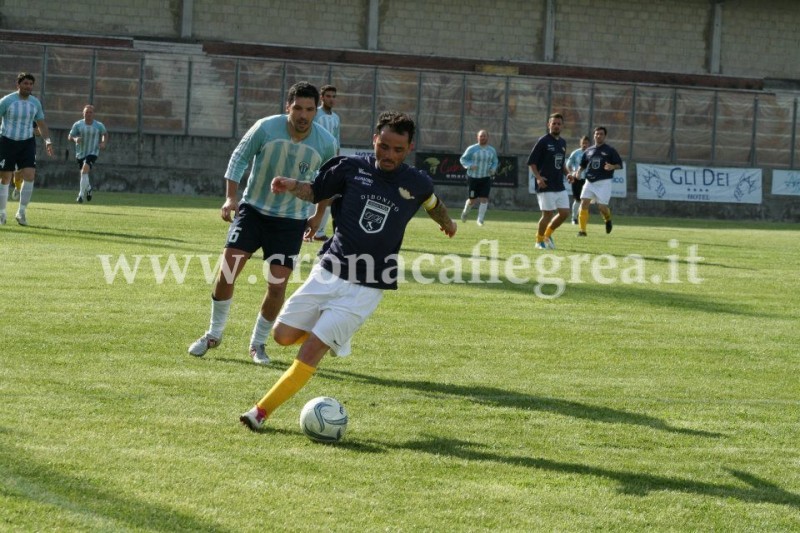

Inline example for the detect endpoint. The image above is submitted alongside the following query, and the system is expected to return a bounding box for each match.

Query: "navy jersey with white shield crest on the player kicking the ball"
[312,155,433,289]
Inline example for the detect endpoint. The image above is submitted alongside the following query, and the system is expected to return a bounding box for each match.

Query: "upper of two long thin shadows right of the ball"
[318,369,724,438]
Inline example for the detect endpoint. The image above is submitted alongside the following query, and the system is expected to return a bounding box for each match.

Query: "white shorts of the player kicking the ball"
[275,264,383,357]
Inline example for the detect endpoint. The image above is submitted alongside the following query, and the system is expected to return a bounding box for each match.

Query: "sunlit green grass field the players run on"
[0,190,800,532]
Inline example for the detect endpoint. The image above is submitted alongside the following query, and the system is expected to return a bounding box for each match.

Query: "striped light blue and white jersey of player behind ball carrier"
[225,115,336,220]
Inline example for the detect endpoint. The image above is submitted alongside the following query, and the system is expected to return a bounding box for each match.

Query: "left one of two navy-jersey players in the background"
[528,113,569,249]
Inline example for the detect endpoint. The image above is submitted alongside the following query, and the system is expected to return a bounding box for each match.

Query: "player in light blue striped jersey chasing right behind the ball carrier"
[189,82,336,364]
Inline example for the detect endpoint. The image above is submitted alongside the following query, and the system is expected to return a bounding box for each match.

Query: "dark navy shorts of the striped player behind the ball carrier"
[225,203,306,269]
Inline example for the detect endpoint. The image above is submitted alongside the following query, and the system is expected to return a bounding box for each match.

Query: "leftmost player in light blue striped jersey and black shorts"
[0,72,53,226]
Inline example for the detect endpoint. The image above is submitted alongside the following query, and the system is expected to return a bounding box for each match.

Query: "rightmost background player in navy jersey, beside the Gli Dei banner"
[578,126,622,237]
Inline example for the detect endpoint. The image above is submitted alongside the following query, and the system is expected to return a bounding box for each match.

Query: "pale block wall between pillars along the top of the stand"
[0,0,800,80]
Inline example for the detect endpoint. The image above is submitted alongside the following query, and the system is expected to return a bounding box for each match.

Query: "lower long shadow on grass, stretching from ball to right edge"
[388,437,800,509]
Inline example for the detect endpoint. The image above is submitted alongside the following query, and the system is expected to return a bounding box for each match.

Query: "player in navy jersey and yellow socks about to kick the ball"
[239,112,456,430]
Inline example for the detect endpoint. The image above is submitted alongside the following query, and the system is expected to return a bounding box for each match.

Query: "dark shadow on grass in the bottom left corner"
[0,446,231,532]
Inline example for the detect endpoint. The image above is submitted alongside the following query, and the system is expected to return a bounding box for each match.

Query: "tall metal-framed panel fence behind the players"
[0,41,800,168]
